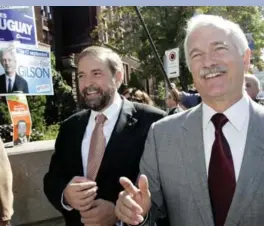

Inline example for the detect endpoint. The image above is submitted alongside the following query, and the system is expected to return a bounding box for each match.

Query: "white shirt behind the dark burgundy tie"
[202,93,249,180]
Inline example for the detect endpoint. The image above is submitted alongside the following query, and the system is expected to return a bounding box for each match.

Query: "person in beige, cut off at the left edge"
[0,138,14,226]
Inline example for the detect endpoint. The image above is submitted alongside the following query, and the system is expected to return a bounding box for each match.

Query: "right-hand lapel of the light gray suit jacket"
[227,101,264,224]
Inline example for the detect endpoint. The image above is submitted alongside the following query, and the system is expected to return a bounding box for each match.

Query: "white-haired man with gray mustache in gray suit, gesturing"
[116,15,264,226]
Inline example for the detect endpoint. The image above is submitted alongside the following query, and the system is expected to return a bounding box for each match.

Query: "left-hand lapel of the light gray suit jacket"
[182,104,214,226]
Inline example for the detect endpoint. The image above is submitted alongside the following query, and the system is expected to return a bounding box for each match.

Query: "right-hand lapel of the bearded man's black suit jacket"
[97,99,137,179]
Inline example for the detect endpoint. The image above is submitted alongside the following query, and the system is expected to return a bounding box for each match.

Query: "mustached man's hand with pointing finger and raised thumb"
[115,175,151,225]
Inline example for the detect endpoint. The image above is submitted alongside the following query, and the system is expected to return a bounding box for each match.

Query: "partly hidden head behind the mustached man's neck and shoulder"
[245,74,261,102]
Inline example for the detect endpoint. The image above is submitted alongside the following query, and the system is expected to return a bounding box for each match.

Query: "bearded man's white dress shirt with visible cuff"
[61,92,122,211]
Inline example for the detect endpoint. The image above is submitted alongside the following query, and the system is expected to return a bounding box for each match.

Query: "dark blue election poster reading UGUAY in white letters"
[0,6,38,46]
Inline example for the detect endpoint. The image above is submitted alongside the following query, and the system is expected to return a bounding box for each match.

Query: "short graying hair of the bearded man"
[76,46,124,86]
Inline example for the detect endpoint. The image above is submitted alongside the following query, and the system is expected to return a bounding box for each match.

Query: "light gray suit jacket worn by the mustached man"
[140,101,264,226]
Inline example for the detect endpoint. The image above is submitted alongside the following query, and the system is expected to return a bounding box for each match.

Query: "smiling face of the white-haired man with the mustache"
[187,26,250,105]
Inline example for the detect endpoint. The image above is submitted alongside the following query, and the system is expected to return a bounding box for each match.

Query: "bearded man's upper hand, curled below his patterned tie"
[63,177,98,211]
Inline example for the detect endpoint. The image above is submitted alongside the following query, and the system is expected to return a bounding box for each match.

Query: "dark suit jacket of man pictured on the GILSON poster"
[0,74,28,94]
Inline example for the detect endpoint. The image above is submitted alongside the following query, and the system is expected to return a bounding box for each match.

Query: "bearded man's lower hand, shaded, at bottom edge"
[80,199,118,226]
